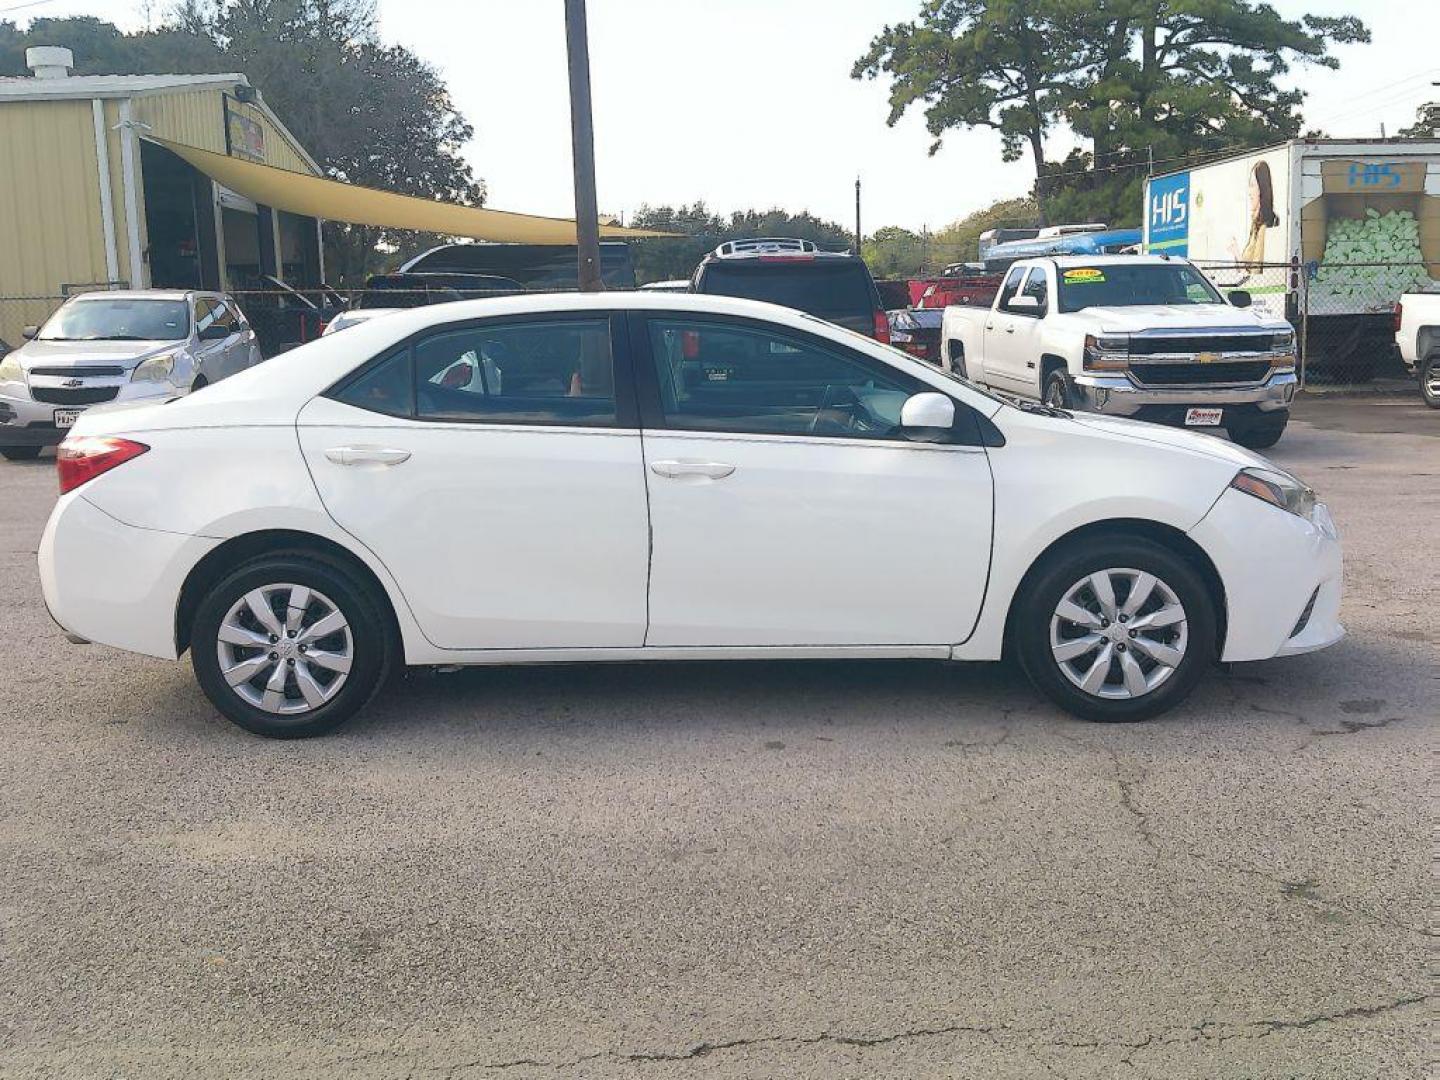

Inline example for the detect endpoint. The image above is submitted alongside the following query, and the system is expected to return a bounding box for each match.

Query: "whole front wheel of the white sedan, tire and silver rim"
[1012,533,1217,721]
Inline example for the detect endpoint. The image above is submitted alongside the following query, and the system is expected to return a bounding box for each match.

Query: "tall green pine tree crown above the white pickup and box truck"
[852,0,1369,220]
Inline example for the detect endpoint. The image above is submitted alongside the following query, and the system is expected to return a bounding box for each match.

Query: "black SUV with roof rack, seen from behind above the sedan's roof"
[691,238,890,343]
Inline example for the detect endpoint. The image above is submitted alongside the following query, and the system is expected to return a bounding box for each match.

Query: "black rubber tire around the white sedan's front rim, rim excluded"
[1011,533,1217,723]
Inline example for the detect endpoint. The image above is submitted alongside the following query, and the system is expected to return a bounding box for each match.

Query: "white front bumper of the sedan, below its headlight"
[1189,488,1345,661]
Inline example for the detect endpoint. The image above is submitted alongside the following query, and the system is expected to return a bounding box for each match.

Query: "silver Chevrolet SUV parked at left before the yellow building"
[0,289,262,461]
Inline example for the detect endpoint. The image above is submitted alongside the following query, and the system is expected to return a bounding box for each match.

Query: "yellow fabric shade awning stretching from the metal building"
[147,137,674,243]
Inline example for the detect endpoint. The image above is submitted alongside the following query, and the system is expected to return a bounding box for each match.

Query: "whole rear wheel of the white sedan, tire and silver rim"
[190,553,396,739]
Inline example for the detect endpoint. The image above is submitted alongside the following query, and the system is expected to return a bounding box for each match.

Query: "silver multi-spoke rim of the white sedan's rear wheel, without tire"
[216,583,354,716]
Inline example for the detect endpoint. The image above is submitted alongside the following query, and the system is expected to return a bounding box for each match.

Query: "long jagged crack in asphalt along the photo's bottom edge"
[445,994,1431,1077]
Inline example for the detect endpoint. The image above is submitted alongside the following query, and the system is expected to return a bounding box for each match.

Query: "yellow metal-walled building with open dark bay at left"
[0,48,324,344]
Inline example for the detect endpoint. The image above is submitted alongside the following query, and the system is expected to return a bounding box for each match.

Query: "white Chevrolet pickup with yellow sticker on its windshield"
[940,255,1296,449]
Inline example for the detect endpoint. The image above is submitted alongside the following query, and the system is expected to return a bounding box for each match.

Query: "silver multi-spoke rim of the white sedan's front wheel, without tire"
[1050,567,1189,701]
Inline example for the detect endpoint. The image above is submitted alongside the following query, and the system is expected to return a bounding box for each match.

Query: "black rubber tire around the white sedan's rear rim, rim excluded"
[190,552,399,739]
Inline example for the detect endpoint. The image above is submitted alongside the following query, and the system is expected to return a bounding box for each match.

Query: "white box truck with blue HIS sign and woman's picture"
[1143,138,1440,376]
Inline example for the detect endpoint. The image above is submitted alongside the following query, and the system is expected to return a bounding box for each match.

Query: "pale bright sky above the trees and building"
[8,0,1440,233]
